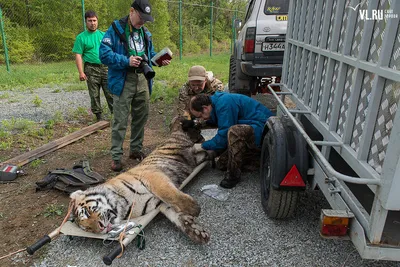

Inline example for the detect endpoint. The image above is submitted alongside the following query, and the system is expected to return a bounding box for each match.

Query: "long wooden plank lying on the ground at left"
[0,121,110,166]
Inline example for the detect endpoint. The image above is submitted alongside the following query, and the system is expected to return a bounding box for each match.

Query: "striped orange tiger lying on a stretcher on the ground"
[70,117,214,244]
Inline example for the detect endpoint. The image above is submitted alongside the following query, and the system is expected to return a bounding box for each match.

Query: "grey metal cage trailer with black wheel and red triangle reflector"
[260,0,400,261]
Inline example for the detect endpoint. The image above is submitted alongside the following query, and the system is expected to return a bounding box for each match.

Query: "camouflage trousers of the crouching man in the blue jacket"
[217,124,261,178]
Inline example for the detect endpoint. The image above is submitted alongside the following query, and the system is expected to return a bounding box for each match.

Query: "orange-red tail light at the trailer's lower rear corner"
[321,209,354,237]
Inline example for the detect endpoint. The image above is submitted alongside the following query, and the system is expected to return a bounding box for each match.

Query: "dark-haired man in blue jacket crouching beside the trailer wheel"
[190,92,273,188]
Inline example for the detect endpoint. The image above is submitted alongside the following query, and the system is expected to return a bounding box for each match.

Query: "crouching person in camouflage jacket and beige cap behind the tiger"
[177,66,224,143]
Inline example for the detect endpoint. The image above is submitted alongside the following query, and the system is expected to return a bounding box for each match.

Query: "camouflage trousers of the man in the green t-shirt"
[84,63,113,114]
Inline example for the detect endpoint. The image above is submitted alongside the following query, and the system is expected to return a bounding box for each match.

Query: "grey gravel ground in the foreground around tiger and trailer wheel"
[35,167,399,267]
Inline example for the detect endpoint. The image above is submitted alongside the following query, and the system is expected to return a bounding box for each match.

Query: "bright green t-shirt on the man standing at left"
[72,30,104,64]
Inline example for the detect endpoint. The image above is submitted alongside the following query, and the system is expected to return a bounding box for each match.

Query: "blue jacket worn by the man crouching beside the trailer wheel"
[202,92,274,150]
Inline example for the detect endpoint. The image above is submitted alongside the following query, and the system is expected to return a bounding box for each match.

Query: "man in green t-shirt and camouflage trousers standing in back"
[72,11,113,121]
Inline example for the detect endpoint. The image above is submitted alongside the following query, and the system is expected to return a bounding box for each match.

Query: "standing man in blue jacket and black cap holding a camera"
[100,0,170,171]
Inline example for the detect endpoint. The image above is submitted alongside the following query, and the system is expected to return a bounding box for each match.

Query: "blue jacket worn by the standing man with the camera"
[99,16,156,96]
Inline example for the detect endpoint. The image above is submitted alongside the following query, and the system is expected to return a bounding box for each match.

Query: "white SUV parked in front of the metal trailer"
[229,0,289,95]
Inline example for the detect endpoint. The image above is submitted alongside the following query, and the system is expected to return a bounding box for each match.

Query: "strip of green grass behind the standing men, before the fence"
[0,53,229,103]
